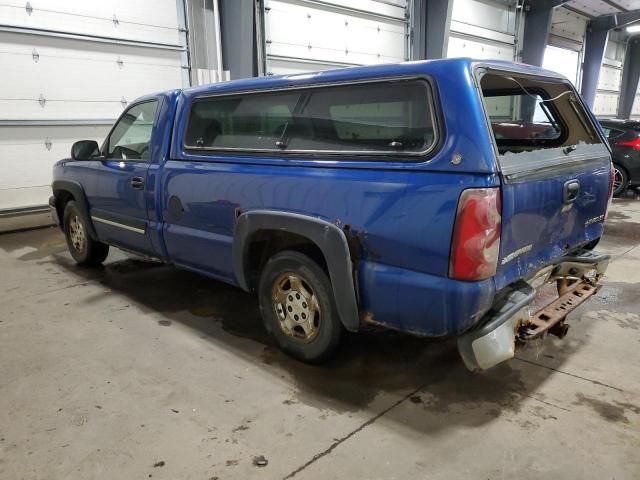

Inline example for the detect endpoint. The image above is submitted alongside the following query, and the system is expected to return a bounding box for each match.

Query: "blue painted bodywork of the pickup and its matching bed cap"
[54,59,608,336]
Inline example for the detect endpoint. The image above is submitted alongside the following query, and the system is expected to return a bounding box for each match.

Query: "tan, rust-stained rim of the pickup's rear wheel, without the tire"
[271,272,320,343]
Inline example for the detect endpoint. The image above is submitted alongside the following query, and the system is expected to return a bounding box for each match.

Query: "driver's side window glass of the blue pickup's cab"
[107,100,158,161]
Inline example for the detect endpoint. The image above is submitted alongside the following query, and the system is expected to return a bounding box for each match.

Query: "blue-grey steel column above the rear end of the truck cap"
[411,0,453,60]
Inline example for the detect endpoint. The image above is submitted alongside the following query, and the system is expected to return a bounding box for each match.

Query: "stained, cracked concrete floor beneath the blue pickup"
[0,199,640,480]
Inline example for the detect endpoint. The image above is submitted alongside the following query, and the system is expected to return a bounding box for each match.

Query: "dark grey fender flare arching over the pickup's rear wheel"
[233,210,360,332]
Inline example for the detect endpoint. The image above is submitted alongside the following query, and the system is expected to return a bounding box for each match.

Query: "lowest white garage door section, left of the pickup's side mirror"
[0,125,110,210]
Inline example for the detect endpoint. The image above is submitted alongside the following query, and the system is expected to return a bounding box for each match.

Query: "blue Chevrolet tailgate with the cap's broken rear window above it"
[480,69,611,289]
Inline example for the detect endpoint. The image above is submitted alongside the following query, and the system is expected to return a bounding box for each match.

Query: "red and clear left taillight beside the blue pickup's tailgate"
[449,188,502,280]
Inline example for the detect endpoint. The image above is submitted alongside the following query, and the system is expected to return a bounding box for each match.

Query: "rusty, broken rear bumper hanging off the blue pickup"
[458,250,610,371]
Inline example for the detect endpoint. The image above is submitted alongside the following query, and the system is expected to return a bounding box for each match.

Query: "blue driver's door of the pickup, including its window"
[91,99,158,254]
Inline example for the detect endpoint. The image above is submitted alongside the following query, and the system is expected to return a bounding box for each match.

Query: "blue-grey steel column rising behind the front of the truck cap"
[218,0,258,80]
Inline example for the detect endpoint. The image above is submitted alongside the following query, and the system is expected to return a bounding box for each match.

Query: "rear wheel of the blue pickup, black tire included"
[258,251,342,363]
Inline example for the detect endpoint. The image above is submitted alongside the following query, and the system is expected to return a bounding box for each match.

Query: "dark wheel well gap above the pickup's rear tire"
[246,230,329,287]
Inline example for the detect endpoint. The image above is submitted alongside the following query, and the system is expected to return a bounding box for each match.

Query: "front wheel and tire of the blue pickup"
[62,200,109,266]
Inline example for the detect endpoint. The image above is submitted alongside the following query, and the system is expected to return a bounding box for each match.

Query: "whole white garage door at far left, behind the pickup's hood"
[0,0,188,218]
